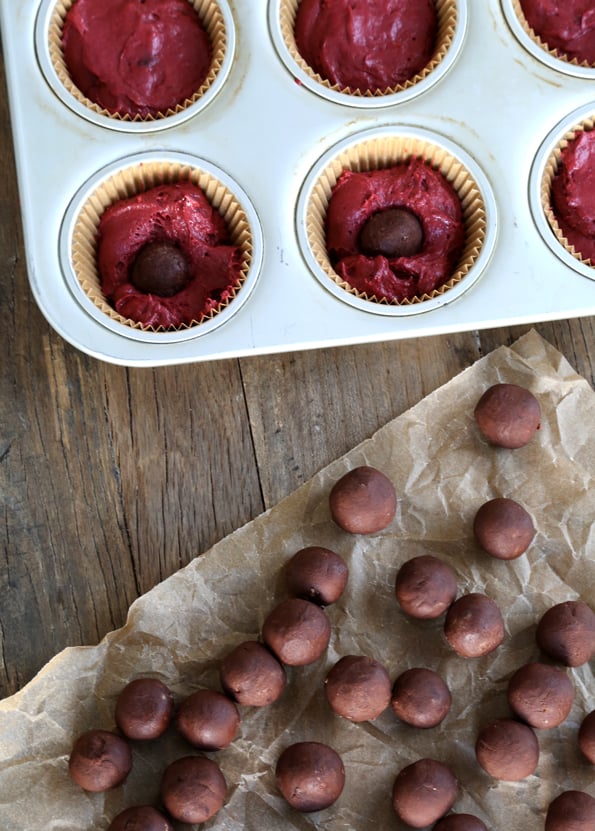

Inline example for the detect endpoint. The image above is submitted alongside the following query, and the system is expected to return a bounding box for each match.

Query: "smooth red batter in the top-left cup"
[62,0,212,117]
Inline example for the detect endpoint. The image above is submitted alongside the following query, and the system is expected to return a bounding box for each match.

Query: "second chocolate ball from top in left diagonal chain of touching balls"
[262,597,331,667]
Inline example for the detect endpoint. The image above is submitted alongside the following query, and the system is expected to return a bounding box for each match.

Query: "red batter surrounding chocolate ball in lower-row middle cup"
[326,159,465,301]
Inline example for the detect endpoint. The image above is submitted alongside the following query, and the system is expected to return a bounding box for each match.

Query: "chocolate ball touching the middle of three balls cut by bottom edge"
[393,759,459,828]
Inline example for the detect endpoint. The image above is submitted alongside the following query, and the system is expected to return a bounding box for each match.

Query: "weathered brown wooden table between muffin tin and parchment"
[0,40,595,698]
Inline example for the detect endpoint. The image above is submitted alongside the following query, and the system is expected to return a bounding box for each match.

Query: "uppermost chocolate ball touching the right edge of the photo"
[536,600,595,667]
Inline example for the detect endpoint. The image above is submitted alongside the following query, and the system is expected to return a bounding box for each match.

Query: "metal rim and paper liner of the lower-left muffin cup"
[58,151,263,343]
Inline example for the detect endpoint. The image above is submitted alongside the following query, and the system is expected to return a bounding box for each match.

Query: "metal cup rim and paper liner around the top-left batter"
[34,0,236,133]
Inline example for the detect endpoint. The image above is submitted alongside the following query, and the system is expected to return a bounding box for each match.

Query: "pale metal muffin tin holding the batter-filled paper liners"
[0,0,595,366]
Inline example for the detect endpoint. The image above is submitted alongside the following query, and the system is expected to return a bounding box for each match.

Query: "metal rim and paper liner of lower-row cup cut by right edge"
[529,103,595,280]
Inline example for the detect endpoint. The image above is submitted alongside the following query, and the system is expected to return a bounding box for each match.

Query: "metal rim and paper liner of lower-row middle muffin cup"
[296,126,498,317]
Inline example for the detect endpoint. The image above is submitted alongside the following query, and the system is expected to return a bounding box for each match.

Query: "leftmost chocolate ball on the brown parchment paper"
[68,730,132,793]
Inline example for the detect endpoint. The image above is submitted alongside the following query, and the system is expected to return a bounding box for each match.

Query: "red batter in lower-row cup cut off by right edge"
[551,130,595,264]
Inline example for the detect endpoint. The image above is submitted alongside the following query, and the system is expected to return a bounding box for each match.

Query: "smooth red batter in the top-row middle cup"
[294,0,438,92]
